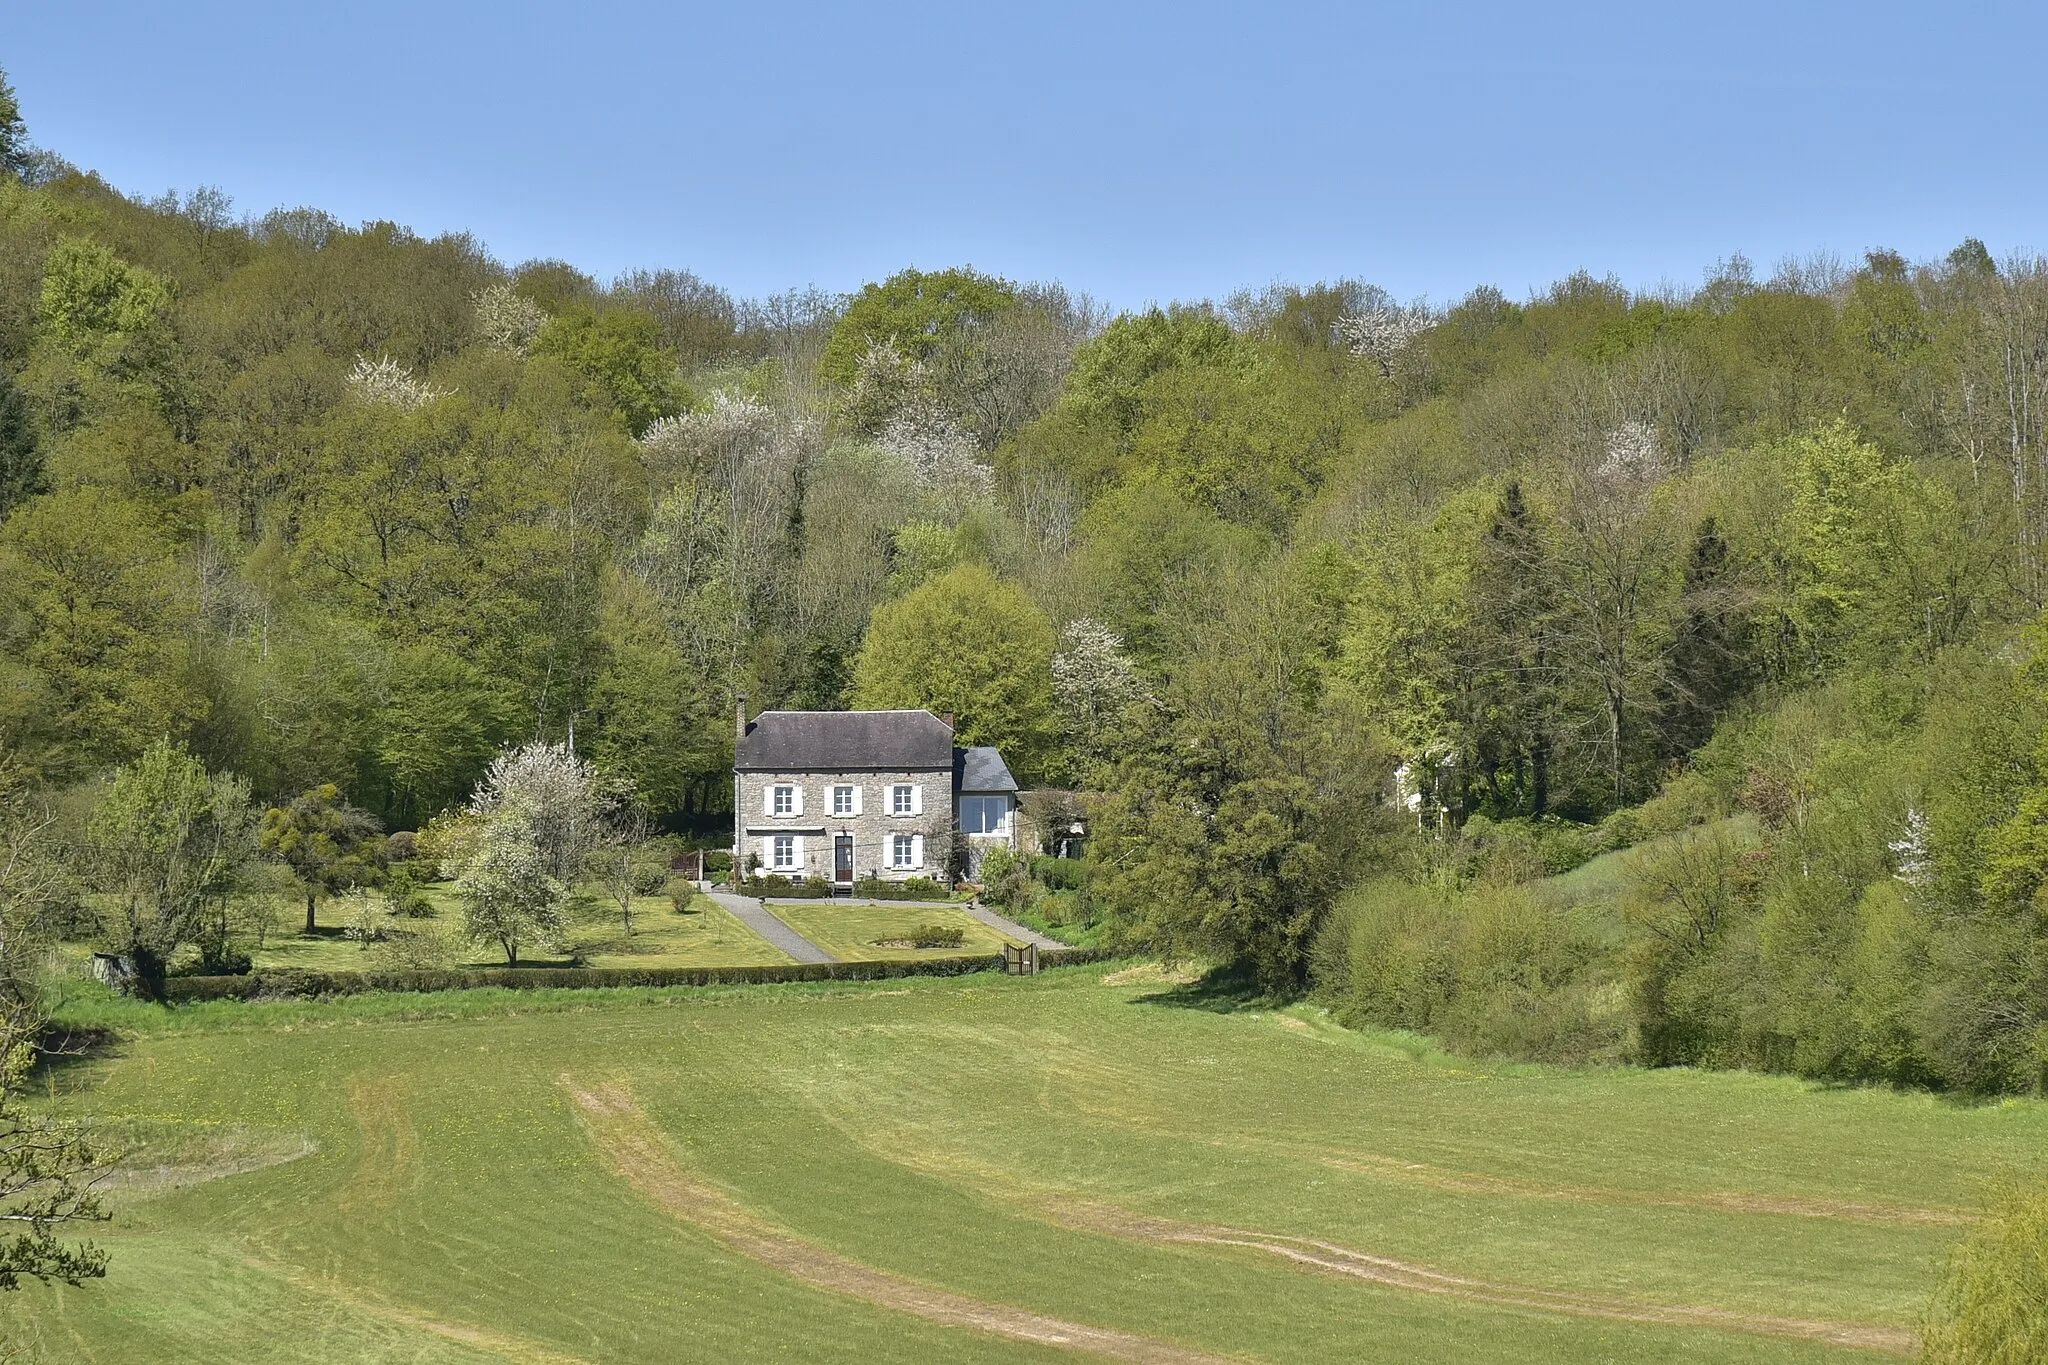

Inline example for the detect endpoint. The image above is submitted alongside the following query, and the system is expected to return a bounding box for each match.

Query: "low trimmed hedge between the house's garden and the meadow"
[164,948,1110,1003]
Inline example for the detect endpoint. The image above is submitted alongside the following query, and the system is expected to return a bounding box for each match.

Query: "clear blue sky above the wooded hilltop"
[0,0,2048,305]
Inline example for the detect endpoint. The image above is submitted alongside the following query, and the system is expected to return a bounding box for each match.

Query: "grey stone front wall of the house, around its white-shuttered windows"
[735,769,952,880]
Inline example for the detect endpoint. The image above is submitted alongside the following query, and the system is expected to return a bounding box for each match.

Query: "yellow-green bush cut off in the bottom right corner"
[1921,1183,2048,1365]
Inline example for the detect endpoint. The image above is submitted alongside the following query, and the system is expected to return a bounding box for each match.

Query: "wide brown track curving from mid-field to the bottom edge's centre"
[561,1076,1229,1365]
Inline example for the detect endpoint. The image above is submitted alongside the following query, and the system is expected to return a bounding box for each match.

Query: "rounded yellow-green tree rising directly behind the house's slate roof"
[852,565,1055,772]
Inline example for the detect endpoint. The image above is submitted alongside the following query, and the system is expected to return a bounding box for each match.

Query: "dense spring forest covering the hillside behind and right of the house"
[0,74,2048,1091]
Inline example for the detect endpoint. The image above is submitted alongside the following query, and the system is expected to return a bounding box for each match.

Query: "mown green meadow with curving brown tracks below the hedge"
[0,966,2048,1365]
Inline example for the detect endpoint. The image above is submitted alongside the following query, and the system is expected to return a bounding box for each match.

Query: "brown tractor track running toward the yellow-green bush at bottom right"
[838,1126,1919,1355]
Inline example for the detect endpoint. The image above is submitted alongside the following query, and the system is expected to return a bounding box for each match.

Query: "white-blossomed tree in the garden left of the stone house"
[455,741,610,964]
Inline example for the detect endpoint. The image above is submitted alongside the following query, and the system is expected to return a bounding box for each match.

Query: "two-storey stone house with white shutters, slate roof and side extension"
[733,712,1018,890]
